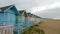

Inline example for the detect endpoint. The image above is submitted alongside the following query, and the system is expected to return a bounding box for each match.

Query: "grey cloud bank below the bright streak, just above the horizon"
[35,8,60,18]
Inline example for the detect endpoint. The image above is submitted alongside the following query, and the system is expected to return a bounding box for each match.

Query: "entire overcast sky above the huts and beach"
[0,0,60,19]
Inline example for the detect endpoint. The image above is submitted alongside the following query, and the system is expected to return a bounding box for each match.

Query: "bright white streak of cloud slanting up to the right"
[31,2,60,13]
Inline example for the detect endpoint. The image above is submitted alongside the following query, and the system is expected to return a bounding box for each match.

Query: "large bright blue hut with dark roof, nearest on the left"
[0,5,19,31]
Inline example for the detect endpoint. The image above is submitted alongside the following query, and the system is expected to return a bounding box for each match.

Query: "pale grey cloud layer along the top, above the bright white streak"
[0,0,53,9]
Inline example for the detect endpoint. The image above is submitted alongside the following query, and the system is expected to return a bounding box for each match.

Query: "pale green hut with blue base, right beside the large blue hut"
[17,10,30,34]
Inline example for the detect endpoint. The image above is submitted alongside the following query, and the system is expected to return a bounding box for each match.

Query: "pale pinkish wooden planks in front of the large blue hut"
[0,25,13,34]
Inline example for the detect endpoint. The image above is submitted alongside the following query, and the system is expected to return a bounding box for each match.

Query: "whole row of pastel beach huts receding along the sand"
[0,5,41,34]
